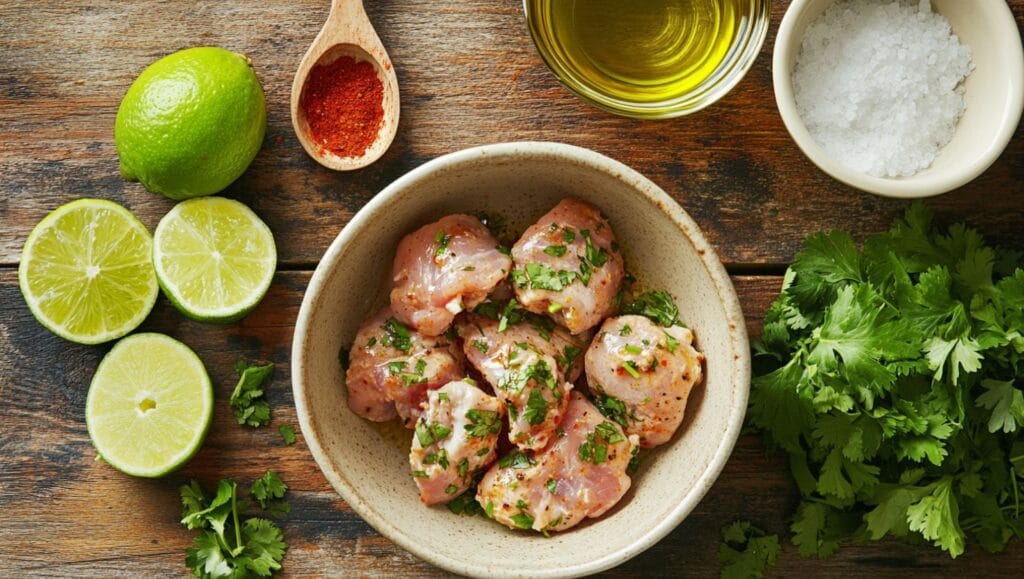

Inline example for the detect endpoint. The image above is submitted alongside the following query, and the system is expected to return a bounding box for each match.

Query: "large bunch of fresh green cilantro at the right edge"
[749,203,1024,557]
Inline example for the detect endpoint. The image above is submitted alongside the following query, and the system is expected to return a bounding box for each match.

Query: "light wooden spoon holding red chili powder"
[292,0,399,171]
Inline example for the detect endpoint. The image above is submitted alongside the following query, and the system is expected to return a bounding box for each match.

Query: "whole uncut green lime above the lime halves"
[114,46,266,199]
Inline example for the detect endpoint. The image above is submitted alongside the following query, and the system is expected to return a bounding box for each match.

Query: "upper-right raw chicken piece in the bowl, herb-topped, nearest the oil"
[512,198,626,334]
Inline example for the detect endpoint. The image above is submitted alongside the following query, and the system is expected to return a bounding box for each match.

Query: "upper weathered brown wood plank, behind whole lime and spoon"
[0,0,1024,265]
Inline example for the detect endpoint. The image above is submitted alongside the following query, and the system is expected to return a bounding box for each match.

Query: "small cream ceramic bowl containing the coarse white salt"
[772,0,1024,198]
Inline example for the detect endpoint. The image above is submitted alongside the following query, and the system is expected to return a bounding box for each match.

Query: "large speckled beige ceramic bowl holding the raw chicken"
[292,142,750,577]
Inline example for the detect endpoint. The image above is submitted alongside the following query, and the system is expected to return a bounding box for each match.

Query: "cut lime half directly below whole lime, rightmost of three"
[153,197,278,323]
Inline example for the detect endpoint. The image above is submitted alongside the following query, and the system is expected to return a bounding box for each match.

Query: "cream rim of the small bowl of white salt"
[772,0,1024,199]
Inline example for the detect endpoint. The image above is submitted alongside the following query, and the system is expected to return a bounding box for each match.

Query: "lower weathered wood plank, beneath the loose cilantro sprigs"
[0,268,1024,577]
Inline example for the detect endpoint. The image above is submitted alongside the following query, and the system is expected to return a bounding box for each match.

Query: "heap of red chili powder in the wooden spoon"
[299,56,384,157]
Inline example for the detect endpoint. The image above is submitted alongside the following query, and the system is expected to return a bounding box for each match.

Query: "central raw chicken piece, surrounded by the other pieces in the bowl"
[457,311,586,450]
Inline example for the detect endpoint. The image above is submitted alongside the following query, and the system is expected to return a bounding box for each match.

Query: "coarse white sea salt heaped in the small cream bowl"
[793,0,974,177]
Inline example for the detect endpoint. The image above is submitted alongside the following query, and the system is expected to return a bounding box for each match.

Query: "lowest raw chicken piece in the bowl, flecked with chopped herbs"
[476,391,637,532]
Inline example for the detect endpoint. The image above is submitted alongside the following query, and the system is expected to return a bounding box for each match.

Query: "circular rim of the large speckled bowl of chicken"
[291,141,751,577]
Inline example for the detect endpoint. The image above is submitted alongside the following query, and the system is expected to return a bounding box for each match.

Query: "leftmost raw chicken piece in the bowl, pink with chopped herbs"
[345,306,465,428]
